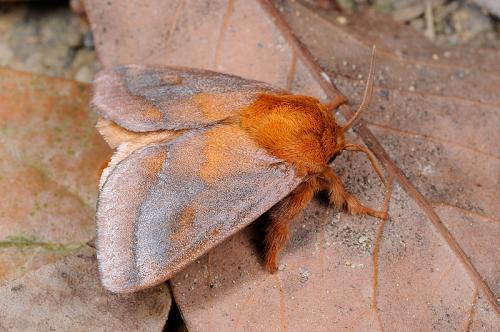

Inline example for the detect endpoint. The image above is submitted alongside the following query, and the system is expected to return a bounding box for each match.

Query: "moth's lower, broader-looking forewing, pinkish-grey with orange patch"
[96,125,301,292]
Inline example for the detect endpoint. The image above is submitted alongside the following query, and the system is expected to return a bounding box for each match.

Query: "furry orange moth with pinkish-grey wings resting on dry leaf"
[92,47,387,292]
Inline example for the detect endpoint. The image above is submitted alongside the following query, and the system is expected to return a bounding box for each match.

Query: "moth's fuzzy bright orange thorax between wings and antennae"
[241,94,342,175]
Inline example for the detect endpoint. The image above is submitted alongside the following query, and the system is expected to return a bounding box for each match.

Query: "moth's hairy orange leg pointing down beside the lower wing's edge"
[265,178,319,272]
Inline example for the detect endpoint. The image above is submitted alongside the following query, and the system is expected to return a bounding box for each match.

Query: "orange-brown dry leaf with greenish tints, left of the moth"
[0,69,110,283]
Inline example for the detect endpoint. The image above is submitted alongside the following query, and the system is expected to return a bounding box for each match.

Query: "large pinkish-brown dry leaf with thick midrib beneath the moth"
[86,0,500,331]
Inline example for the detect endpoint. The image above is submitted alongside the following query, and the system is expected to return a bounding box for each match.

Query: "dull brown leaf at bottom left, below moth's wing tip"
[0,247,171,331]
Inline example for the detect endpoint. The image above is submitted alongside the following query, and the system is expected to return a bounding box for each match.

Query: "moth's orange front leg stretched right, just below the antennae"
[320,168,388,219]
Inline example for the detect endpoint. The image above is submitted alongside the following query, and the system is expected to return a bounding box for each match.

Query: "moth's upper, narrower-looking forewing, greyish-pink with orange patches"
[92,65,283,132]
